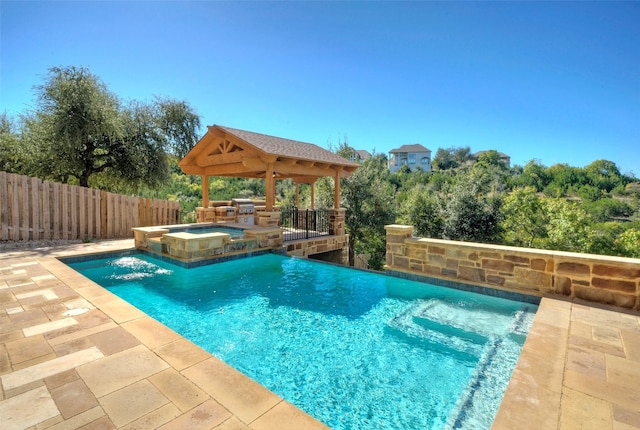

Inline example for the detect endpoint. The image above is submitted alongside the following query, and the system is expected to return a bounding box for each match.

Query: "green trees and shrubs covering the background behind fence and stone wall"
[0,67,640,269]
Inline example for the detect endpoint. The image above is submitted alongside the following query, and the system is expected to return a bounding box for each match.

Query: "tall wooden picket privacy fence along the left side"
[0,172,180,241]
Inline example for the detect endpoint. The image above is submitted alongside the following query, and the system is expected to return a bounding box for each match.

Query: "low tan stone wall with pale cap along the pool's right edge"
[385,225,640,310]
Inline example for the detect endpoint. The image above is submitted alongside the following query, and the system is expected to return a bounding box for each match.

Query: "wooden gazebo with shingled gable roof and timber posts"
[179,125,360,211]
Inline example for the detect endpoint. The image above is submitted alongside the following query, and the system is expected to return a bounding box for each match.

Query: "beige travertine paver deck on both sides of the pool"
[0,240,640,430]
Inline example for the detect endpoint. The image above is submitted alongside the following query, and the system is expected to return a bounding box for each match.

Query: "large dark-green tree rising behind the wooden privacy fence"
[31,67,200,187]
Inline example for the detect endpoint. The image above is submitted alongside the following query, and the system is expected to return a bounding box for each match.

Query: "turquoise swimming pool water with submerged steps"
[70,254,537,429]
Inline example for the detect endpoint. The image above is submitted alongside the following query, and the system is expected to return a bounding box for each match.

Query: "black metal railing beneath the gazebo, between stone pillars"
[280,207,329,242]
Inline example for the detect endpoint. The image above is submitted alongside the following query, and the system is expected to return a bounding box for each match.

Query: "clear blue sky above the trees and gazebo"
[0,0,640,176]
